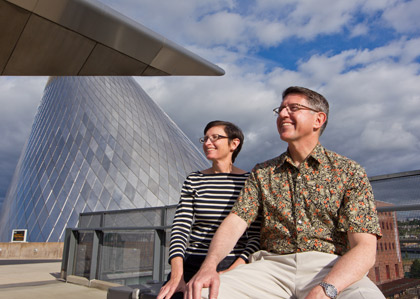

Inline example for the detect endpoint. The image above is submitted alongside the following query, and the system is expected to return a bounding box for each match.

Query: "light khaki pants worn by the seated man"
[202,251,385,299]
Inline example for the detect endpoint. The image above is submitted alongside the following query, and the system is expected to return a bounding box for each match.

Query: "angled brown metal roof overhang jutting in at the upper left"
[0,0,224,76]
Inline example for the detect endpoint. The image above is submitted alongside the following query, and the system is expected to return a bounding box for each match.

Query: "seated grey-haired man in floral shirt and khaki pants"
[186,87,384,299]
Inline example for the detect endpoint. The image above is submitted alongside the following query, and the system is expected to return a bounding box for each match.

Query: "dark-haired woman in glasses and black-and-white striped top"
[157,120,259,299]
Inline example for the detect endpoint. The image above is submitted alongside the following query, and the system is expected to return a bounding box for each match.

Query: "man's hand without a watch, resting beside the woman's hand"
[184,267,220,299]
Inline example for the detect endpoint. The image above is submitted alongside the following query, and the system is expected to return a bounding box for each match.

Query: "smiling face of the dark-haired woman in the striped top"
[203,126,236,161]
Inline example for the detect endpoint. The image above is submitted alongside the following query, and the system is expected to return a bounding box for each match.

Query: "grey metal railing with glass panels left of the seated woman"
[61,206,175,285]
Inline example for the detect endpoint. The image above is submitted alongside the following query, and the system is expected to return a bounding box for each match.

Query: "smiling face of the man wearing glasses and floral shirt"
[277,94,317,143]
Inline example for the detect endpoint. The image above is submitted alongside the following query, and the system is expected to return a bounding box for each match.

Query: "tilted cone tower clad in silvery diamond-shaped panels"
[0,77,209,242]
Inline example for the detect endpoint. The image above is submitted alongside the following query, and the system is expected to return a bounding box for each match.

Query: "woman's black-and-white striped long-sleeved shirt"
[169,171,260,261]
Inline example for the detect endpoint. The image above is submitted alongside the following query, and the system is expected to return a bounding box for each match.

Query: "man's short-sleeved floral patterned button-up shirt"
[232,144,382,255]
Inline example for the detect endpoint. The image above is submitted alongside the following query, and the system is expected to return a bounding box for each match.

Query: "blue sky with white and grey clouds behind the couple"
[0,0,420,207]
